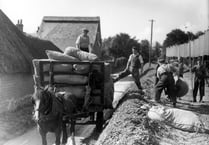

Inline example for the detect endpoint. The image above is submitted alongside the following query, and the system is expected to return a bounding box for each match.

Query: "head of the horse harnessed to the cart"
[32,86,53,121]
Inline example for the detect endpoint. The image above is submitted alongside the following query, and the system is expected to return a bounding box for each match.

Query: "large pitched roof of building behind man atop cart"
[38,16,101,54]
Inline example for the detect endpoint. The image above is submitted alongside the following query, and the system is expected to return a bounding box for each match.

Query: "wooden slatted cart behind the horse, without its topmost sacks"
[33,59,114,145]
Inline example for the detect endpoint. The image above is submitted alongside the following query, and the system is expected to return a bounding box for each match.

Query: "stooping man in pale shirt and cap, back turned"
[155,57,177,107]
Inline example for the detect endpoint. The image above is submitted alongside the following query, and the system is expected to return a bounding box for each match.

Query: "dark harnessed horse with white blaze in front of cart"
[32,86,76,145]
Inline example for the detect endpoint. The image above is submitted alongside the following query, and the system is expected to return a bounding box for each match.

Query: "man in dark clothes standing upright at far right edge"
[192,59,208,102]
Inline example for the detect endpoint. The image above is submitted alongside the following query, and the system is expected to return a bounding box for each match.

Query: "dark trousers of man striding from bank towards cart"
[117,69,142,89]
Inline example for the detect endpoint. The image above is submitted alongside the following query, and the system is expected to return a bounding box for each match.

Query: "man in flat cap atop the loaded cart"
[76,28,90,52]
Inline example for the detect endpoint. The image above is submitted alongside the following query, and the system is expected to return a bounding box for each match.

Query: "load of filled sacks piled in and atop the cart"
[33,47,114,108]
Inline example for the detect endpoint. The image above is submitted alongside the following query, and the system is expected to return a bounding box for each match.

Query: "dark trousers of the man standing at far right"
[193,78,205,102]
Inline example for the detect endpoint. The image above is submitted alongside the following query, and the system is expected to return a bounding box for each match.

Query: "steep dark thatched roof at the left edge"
[0,10,59,73]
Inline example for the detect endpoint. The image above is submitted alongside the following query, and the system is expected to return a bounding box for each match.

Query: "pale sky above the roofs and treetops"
[0,0,209,43]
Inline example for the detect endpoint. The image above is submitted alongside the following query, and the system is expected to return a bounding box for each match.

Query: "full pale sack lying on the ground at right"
[142,105,206,133]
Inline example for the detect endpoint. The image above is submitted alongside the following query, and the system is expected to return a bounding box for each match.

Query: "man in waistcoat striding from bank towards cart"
[114,46,144,89]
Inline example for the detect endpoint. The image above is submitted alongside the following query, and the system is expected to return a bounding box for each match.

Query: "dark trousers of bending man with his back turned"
[155,73,176,103]
